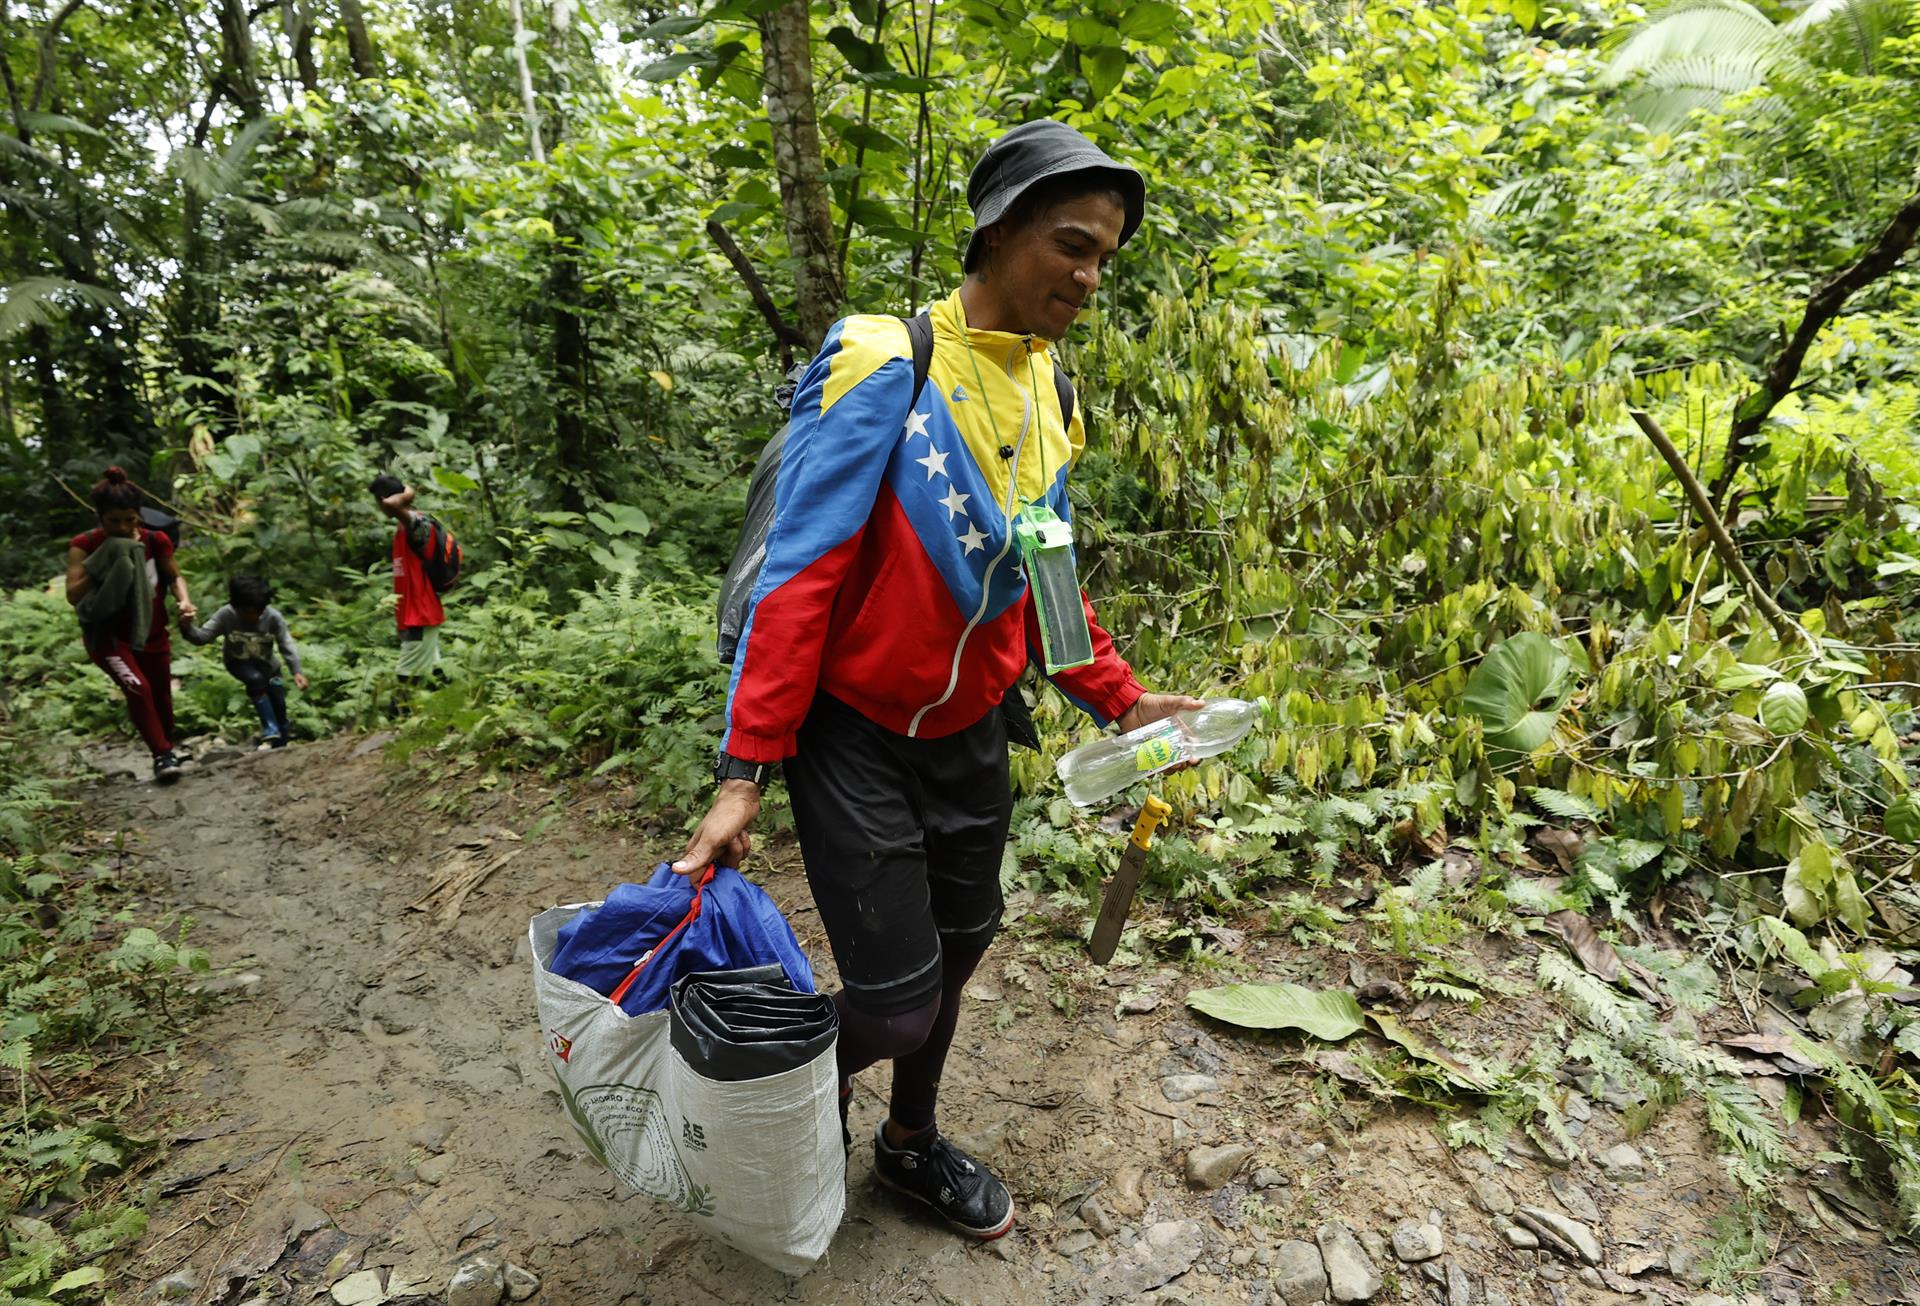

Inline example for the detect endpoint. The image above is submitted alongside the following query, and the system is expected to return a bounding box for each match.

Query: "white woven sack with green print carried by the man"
[528,903,847,1273]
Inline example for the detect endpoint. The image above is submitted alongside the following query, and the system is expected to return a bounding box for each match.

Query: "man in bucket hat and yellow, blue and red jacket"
[674,121,1202,1239]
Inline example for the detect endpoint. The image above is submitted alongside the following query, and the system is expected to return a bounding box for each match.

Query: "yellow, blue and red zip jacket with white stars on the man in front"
[722,280,1142,762]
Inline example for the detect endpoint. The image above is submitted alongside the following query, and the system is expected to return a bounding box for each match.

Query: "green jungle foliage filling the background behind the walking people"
[0,0,1920,1275]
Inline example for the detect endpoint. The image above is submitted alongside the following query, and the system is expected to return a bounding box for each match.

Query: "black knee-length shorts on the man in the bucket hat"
[787,693,1014,1016]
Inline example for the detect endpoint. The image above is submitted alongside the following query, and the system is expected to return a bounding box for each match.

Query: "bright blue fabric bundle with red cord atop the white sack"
[547,862,814,1016]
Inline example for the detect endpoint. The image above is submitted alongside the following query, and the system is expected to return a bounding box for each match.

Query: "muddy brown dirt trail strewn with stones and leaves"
[90,739,1916,1306]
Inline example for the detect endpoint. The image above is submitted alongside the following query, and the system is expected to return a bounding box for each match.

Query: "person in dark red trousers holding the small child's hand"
[67,467,200,784]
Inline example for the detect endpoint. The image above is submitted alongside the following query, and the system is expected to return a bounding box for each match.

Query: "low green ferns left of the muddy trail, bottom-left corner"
[0,729,211,1306]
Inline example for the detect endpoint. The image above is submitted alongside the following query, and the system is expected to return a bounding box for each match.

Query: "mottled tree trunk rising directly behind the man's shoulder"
[758,0,841,350]
